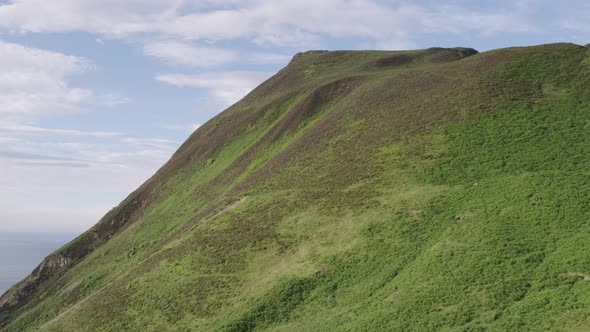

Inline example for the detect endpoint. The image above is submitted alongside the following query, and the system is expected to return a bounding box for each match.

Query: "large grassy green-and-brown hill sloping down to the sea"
[0,43,590,331]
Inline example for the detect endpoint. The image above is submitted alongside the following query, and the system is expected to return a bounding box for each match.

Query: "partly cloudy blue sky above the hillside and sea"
[0,0,590,233]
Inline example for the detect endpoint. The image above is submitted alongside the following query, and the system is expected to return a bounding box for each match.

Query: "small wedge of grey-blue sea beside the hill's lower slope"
[0,232,76,294]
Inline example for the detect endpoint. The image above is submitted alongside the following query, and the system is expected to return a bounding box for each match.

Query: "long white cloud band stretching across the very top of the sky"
[0,0,536,49]
